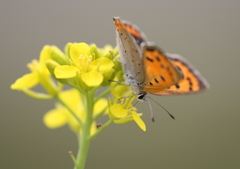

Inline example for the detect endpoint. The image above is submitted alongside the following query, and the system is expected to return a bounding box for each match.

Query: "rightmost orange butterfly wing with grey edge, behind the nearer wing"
[152,53,209,95]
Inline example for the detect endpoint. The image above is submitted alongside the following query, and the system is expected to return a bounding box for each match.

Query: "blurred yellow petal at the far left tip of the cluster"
[11,72,39,90]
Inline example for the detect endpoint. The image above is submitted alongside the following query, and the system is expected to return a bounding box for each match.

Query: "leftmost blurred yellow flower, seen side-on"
[11,46,60,99]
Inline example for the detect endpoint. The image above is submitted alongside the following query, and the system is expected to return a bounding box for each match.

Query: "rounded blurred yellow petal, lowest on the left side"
[43,108,68,129]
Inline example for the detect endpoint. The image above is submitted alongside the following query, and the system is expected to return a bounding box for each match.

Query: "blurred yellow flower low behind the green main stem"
[43,89,107,134]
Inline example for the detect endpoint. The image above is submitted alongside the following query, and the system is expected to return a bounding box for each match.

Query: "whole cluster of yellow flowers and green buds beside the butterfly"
[11,43,146,133]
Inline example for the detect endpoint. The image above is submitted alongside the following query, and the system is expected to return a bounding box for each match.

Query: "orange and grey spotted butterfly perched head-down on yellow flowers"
[113,17,209,121]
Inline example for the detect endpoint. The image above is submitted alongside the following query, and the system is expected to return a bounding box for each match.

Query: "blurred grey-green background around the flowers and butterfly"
[0,0,240,169]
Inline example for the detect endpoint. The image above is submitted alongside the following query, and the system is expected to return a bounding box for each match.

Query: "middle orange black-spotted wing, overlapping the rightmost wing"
[141,42,183,93]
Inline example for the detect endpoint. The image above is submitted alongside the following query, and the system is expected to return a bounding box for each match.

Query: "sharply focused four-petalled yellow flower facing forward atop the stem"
[54,43,114,90]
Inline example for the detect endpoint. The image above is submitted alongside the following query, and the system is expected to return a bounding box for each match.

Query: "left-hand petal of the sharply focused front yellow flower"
[54,65,78,79]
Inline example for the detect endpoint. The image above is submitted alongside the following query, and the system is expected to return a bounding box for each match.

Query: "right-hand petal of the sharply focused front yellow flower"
[90,58,114,71]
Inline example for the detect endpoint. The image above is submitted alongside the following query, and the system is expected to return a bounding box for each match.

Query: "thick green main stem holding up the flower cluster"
[74,91,95,169]
